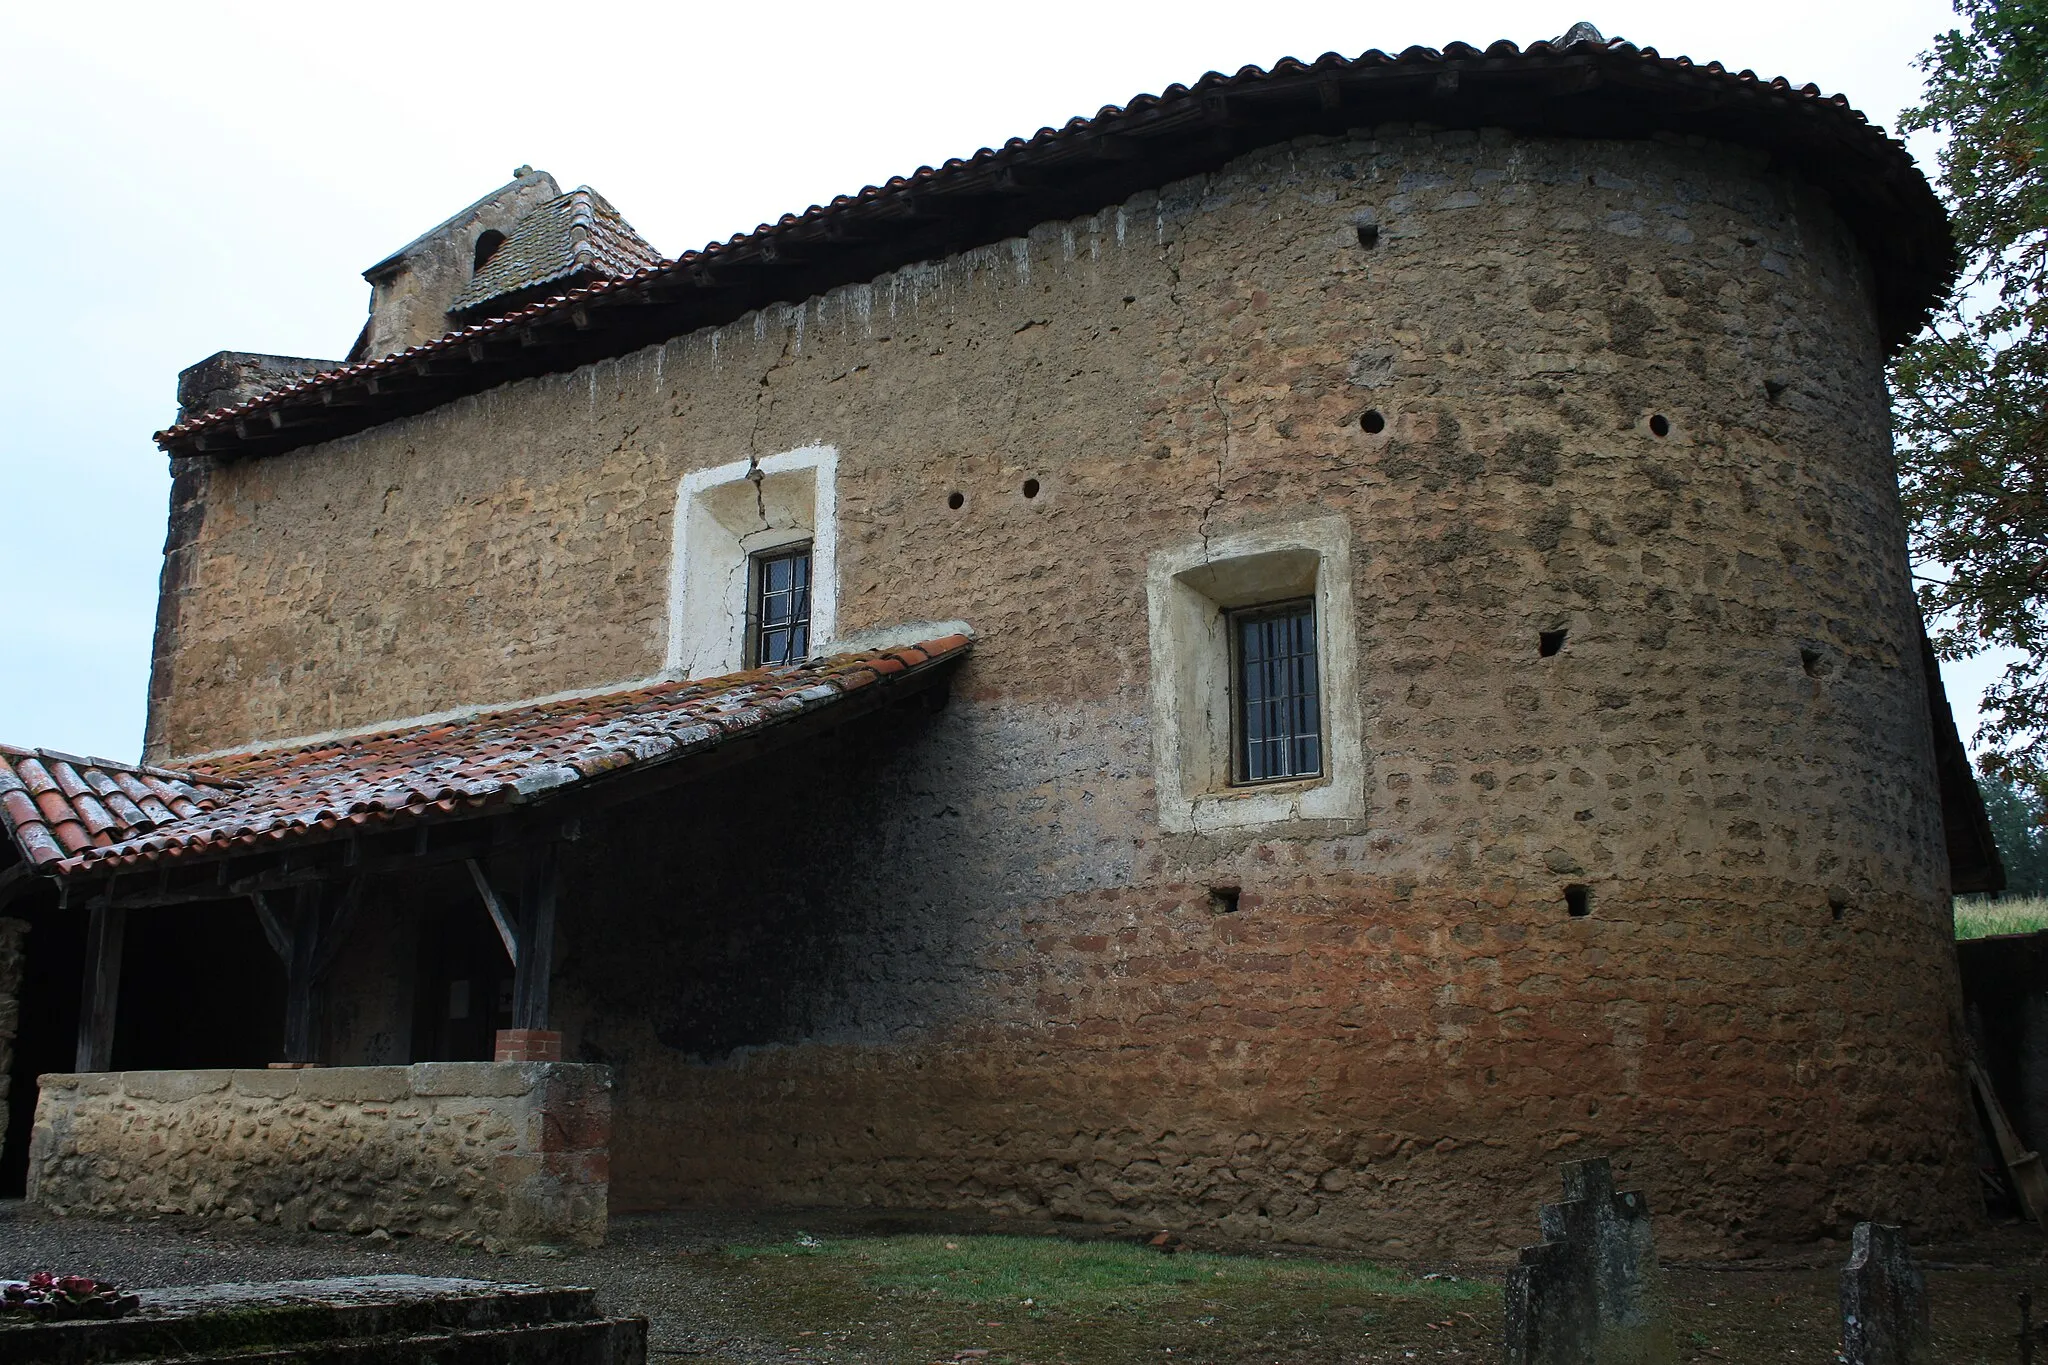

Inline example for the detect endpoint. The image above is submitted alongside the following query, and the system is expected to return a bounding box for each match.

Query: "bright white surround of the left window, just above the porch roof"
[662,446,840,677]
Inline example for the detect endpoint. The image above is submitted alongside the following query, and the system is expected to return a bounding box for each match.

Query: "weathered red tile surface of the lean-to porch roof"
[0,634,971,878]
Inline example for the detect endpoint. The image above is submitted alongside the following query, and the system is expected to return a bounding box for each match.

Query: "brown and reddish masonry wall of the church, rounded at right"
[150,127,1974,1250]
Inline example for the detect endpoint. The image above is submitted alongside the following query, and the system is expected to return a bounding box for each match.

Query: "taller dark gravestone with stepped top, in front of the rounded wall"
[1505,1158,1677,1365]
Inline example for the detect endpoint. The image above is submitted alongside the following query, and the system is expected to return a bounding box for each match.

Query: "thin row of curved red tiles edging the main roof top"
[156,27,1956,454]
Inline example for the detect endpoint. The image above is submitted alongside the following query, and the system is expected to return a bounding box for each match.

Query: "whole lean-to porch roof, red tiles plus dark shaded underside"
[0,634,973,905]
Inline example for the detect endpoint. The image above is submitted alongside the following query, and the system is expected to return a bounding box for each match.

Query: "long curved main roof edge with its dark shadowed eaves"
[156,31,1958,458]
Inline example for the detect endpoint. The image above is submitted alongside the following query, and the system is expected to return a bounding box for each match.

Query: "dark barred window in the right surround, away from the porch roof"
[1231,600,1323,784]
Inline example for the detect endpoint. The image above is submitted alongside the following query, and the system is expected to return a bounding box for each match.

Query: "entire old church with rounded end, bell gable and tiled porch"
[0,25,2001,1254]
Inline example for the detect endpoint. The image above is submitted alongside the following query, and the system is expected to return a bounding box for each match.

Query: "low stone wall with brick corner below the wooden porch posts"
[29,1062,612,1250]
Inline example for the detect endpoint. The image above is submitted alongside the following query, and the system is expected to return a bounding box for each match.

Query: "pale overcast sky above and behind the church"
[0,0,2015,757]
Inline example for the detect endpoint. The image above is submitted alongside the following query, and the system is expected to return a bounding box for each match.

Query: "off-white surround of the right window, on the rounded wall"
[1145,516,1366,833]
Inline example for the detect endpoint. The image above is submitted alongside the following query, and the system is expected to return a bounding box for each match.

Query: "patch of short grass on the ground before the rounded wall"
[692,1234,1501,1365]
